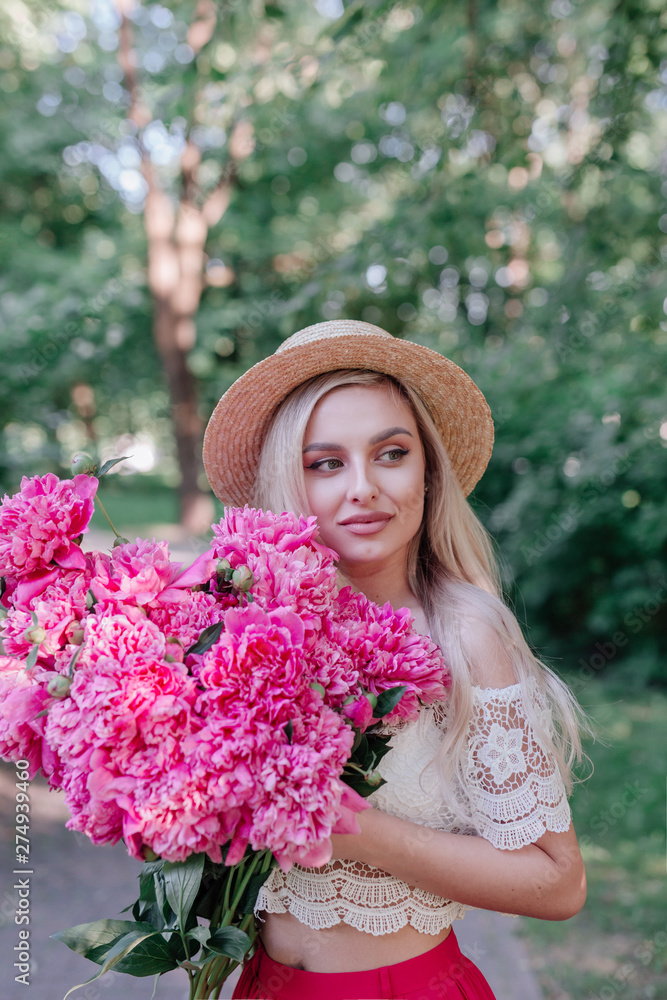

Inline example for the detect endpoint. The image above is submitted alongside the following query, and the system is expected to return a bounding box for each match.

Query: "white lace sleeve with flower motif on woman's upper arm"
[465,684,570,850]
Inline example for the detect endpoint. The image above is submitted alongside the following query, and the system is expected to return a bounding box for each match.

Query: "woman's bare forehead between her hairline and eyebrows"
[306,383,419,438]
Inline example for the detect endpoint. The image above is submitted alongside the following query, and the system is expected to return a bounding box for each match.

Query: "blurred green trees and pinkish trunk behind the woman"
[0,0,667,685]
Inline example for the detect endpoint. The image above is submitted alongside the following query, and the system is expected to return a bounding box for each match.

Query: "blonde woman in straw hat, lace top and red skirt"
[204,321,586,1000]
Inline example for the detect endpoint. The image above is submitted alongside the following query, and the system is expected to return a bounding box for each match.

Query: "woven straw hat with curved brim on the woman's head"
[204,320,493,506]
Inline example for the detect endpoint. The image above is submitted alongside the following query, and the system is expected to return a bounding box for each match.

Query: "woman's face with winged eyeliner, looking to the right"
[303,385,425,575]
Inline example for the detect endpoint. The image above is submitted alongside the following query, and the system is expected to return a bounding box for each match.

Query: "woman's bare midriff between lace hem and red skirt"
[259,913,451,972]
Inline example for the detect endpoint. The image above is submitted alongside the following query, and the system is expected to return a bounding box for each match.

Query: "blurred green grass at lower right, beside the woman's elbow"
[521,683,667,1000]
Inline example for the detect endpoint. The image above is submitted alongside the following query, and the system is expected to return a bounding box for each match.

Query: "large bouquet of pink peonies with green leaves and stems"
[0,463,449,1000]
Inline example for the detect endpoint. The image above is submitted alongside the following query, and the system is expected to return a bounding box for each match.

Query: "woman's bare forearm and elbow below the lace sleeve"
[331,809,586,920]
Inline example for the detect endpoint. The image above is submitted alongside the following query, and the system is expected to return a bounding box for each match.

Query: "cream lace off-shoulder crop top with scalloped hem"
[255,684,570,935]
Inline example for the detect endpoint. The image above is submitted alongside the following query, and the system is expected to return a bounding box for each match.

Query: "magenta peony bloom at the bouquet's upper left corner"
[0,473,97,584]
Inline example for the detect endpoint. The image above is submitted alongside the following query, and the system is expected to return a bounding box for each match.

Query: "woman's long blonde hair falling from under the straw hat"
[253,370,589,823]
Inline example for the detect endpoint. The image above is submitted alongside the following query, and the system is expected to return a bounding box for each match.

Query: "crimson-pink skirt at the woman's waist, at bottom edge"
[234,930,495,1000]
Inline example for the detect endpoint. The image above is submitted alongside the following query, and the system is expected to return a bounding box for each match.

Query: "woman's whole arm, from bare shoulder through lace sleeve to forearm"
[332,623,586,920]
